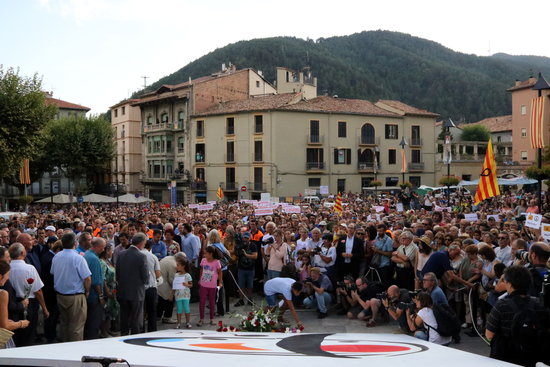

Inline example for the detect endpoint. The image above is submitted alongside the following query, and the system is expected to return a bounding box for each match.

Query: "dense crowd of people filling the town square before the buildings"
[0,191,550,363]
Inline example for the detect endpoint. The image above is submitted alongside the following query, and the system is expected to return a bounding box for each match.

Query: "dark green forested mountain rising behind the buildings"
[134,31,550,122]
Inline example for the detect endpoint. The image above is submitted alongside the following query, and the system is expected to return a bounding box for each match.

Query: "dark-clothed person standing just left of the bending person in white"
[235,232,258,307]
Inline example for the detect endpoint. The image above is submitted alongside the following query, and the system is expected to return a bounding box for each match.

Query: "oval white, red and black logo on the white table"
[123,332,428,358]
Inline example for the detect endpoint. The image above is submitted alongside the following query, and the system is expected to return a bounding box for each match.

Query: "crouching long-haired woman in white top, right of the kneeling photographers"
[405,292,451,346]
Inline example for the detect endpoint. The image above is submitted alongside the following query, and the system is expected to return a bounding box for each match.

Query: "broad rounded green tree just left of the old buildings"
[45,116,115,191]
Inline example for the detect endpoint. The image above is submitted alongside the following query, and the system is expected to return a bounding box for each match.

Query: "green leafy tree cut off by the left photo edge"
[0,65,57,179]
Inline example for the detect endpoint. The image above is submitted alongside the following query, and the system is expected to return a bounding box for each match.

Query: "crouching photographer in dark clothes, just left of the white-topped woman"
[367,285,411,333]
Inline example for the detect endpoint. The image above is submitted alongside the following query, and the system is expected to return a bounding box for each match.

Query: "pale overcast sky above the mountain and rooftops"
[0,0,550,113]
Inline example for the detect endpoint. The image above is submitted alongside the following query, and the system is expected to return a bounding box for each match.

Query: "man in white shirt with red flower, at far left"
[9,242,50,347]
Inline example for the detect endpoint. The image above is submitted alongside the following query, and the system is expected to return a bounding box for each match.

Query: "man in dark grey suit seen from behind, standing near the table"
[116,233,149,335]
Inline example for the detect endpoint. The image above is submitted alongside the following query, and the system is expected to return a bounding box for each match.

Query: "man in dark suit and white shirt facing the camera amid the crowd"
[336,223,365,280]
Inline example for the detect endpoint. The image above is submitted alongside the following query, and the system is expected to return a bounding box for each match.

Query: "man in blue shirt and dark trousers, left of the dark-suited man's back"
[84,237,106,340]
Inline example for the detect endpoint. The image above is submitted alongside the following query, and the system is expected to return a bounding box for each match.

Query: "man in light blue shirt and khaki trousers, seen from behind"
[50,232,92,342]
